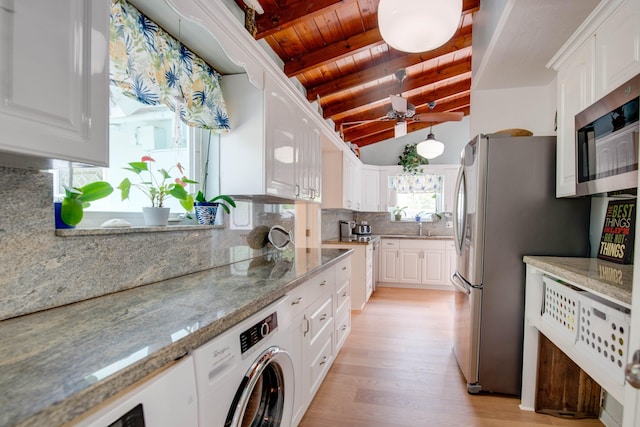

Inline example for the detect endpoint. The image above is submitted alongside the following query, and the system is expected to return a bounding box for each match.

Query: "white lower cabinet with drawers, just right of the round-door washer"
[288,256,351,425]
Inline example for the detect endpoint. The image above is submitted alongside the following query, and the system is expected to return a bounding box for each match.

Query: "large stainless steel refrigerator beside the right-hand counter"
[451,135,590,395]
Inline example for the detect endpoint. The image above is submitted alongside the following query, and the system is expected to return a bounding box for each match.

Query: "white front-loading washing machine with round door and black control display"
[193,297,295,427]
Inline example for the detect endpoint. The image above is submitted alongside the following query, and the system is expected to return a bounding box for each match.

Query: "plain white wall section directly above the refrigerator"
[470,80,556,135]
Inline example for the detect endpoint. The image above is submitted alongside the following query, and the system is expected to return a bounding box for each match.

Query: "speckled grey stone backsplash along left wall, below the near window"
[0,167,295,320]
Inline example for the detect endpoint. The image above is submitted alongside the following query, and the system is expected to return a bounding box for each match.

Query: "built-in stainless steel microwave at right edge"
[575,74,640,196]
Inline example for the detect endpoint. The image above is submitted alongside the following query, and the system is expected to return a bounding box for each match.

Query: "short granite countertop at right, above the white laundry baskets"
[523,256,633,308]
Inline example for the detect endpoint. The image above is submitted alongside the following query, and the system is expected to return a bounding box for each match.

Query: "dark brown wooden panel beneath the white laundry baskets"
[535,334,601,419]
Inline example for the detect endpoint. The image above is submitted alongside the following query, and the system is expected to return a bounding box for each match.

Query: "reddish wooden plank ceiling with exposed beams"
[235,0,480,147]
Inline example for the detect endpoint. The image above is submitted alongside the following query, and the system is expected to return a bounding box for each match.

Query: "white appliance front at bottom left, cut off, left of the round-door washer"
[71,356,198,427]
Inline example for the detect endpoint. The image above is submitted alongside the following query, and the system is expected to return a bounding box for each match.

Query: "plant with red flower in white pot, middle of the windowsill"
[118,156,197,226]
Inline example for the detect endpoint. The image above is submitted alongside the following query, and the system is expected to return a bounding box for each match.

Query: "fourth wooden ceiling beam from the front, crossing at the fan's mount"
[322,57,471,120]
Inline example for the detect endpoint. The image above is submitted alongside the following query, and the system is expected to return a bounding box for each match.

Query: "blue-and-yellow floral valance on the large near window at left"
[109,0,230,133]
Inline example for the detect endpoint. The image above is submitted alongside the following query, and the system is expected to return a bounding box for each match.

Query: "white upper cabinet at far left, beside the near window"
[0,0,109,168]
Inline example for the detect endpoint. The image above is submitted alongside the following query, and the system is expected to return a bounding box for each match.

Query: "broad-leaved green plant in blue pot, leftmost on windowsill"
[54,181,113,228]
